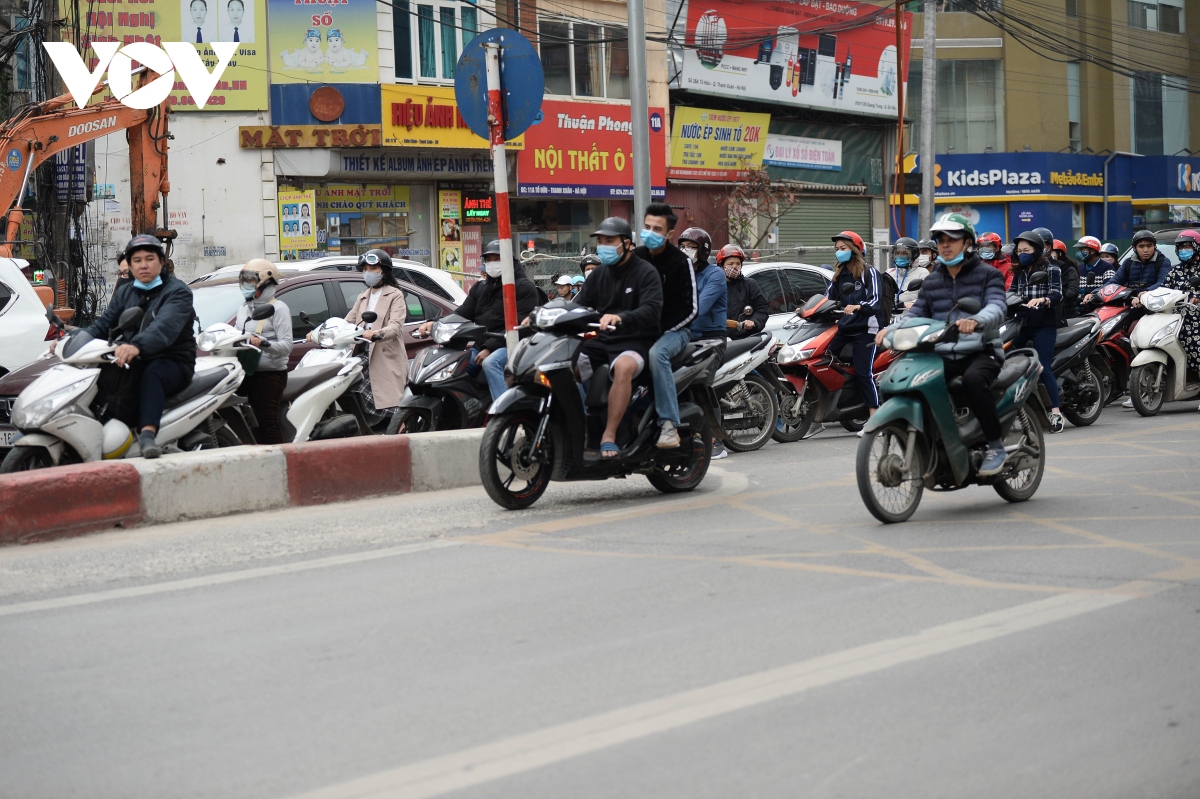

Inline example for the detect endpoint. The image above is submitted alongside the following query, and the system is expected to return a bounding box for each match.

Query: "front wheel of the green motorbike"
[854,423,925,524]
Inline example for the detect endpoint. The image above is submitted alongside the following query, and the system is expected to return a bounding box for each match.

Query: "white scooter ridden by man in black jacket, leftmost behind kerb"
[0,303,246,473]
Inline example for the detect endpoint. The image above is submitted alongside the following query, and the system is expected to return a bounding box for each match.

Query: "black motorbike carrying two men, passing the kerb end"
[479,299,725,510]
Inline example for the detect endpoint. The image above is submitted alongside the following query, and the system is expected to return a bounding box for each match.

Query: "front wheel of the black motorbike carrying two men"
[479,410,551,510]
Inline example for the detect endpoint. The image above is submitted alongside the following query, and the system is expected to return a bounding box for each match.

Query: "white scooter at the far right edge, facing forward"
[1129,279,1200,416]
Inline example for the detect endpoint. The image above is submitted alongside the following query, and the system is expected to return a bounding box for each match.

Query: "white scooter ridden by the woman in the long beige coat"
[282,311,378,443]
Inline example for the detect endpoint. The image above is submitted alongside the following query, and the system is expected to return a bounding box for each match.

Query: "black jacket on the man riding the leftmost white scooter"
[86,272,196,367]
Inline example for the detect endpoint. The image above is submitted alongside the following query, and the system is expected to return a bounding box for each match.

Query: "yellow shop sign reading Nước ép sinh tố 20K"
[670,107,770,180]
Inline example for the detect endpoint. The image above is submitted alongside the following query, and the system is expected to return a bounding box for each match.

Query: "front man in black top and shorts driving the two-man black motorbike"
[575,216,674,458]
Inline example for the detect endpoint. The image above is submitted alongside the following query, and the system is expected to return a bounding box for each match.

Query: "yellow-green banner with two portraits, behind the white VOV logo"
[79,0,268,112]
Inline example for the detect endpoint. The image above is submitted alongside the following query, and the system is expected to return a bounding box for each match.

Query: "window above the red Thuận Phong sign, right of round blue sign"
[538,19,629,100]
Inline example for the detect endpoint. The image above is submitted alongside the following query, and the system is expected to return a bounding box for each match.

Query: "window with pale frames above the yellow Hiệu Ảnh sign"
[392,0,479,82]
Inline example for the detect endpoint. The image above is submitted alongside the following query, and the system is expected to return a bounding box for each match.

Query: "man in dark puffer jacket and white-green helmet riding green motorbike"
[875,214,1007,476]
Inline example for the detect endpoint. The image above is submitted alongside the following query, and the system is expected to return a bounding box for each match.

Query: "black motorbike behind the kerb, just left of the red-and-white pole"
[388,314,492,434]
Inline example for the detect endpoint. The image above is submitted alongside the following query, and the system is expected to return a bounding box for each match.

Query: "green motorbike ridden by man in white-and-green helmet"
[856,299,1050,524]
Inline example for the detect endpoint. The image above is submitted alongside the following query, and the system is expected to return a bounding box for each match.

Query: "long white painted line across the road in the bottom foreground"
[288,585,1133,799]
